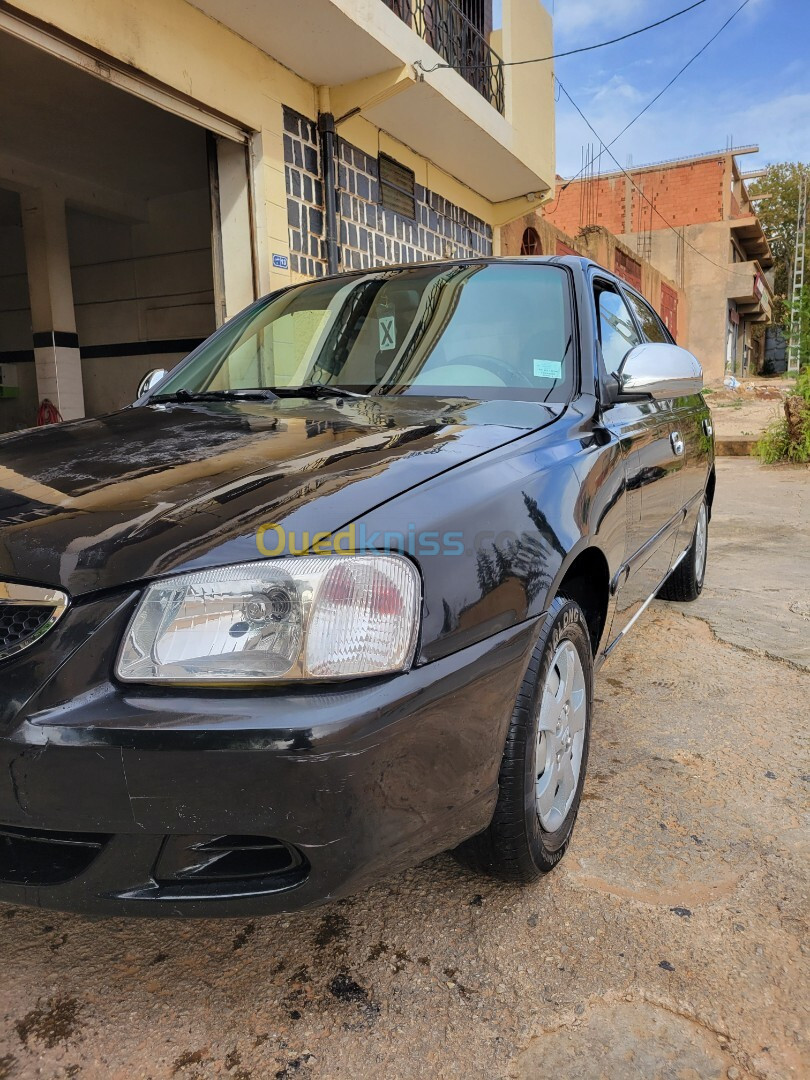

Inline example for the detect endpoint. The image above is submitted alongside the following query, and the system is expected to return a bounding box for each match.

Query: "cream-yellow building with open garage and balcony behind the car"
[0,0,554,432]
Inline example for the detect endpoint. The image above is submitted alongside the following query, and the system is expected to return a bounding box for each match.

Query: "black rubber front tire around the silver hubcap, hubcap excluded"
[455,596,593,882]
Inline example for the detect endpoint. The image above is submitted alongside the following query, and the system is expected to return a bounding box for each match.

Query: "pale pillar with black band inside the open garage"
[21,191,84,420]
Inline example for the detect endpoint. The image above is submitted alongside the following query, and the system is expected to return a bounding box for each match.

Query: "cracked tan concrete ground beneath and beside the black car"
[0,460,810,1080]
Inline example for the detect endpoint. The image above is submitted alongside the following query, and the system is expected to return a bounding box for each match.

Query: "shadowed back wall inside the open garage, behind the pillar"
[0,180,214,432]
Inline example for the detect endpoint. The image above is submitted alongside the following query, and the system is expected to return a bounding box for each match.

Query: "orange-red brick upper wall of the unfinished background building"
[543,158,726,235]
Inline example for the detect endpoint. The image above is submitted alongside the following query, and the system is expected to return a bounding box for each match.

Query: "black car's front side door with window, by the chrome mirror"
[595,279,683,636]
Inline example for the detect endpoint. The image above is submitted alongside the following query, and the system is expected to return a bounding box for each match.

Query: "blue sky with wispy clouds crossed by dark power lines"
[495,0,810,177]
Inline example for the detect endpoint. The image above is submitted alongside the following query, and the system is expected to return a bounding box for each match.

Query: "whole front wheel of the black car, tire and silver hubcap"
[457,596,593,881]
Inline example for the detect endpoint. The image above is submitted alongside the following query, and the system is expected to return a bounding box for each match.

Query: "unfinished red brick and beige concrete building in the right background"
[543,146,773,381]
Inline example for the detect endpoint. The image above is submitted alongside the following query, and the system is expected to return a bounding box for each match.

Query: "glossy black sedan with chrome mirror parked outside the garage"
[0,257,715,915]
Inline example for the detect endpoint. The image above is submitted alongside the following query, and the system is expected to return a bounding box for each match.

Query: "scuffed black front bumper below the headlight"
[0,599,540,916]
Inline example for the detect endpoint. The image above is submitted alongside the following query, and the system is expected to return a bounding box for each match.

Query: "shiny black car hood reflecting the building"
[0,396,563,596]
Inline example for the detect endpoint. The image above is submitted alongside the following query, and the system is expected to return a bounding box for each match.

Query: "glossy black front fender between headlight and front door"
[355,401,625,663]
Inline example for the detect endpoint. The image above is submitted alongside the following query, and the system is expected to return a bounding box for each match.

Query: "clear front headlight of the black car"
[116,555,420,685]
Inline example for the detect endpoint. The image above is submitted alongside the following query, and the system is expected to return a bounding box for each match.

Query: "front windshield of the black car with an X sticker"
[156,262,575,402]
